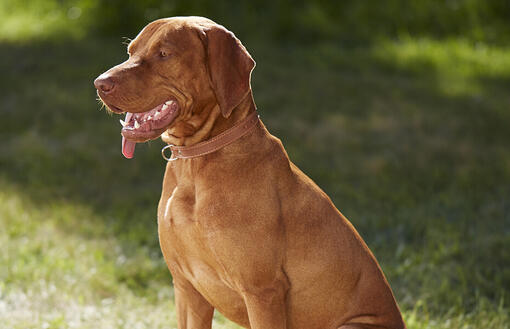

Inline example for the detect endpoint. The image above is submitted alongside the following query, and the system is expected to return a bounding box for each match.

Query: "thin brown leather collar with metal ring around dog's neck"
[161,111,259,161]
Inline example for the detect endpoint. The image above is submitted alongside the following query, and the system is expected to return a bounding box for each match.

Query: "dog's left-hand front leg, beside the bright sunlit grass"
[174,278,214,329]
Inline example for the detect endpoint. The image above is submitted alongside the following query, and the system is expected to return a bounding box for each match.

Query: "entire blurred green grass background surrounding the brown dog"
[0,0,510,329]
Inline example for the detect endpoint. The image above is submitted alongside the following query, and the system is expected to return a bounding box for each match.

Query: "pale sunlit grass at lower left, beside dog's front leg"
[0,181,175,329]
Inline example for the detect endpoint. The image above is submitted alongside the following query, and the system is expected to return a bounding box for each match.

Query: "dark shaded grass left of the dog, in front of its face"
[0,40,164,240]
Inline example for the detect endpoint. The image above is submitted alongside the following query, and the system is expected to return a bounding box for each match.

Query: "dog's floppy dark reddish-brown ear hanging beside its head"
[202,25,255,118]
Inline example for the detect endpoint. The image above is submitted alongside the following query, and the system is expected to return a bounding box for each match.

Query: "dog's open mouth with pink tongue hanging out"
[120,99,179,159]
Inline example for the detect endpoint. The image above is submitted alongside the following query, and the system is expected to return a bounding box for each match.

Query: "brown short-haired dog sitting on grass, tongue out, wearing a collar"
[94,17,405,329]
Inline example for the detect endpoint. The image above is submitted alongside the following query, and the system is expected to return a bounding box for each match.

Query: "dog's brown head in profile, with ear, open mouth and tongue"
[94,17,255,158]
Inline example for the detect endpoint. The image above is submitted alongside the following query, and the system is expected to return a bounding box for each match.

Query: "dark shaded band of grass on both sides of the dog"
[0,39,510,313]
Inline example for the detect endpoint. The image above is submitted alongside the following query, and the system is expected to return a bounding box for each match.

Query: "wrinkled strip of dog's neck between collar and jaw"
[161,91,256,146]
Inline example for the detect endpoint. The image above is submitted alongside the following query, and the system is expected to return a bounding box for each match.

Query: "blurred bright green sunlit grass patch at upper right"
[373,38,510,96]
